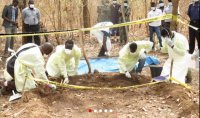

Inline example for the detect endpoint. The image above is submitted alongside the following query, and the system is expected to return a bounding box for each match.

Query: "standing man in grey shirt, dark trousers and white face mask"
[22,0,41,45]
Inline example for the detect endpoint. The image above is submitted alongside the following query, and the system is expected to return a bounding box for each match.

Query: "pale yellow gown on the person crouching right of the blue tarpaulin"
[119,41,153,74]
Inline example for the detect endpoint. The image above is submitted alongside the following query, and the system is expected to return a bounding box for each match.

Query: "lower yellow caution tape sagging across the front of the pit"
[27,77,168,90]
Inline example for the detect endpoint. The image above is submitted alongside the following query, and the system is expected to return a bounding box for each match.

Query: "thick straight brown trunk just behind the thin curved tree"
[82,0,90,34]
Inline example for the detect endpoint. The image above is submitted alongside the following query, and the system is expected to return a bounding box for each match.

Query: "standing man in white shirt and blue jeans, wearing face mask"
[148,2,162,50]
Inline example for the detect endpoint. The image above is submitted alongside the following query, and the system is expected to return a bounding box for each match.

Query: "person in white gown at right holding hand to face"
[161,28,189,83]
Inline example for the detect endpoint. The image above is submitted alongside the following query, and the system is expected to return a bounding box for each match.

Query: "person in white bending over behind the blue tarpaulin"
[91,22,113,57]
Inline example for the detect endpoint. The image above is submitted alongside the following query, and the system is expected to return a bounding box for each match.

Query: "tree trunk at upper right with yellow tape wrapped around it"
[170,0,179,31]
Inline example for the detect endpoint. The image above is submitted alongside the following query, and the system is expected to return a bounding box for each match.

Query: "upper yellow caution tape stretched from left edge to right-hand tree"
[0,14,172,37]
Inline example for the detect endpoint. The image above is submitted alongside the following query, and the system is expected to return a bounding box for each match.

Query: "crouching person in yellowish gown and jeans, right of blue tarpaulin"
[119,41,153,78]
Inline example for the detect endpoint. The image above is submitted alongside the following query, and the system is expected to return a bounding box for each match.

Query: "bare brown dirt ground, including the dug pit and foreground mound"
[0,38,199,118]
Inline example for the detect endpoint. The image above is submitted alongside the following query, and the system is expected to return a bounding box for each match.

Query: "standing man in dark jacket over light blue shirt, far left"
[2,0,18,56]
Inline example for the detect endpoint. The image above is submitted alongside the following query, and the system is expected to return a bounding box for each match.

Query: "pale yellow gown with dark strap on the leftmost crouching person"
[4,43,48,92]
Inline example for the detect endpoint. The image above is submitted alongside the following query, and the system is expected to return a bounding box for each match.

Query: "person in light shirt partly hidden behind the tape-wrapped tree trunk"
[163,0,180,31]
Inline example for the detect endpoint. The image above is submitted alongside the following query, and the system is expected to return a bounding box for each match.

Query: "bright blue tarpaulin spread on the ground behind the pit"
[78,56,159,74]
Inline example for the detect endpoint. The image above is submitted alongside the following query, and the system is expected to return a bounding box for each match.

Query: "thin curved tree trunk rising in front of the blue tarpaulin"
[77,0,91,73]
